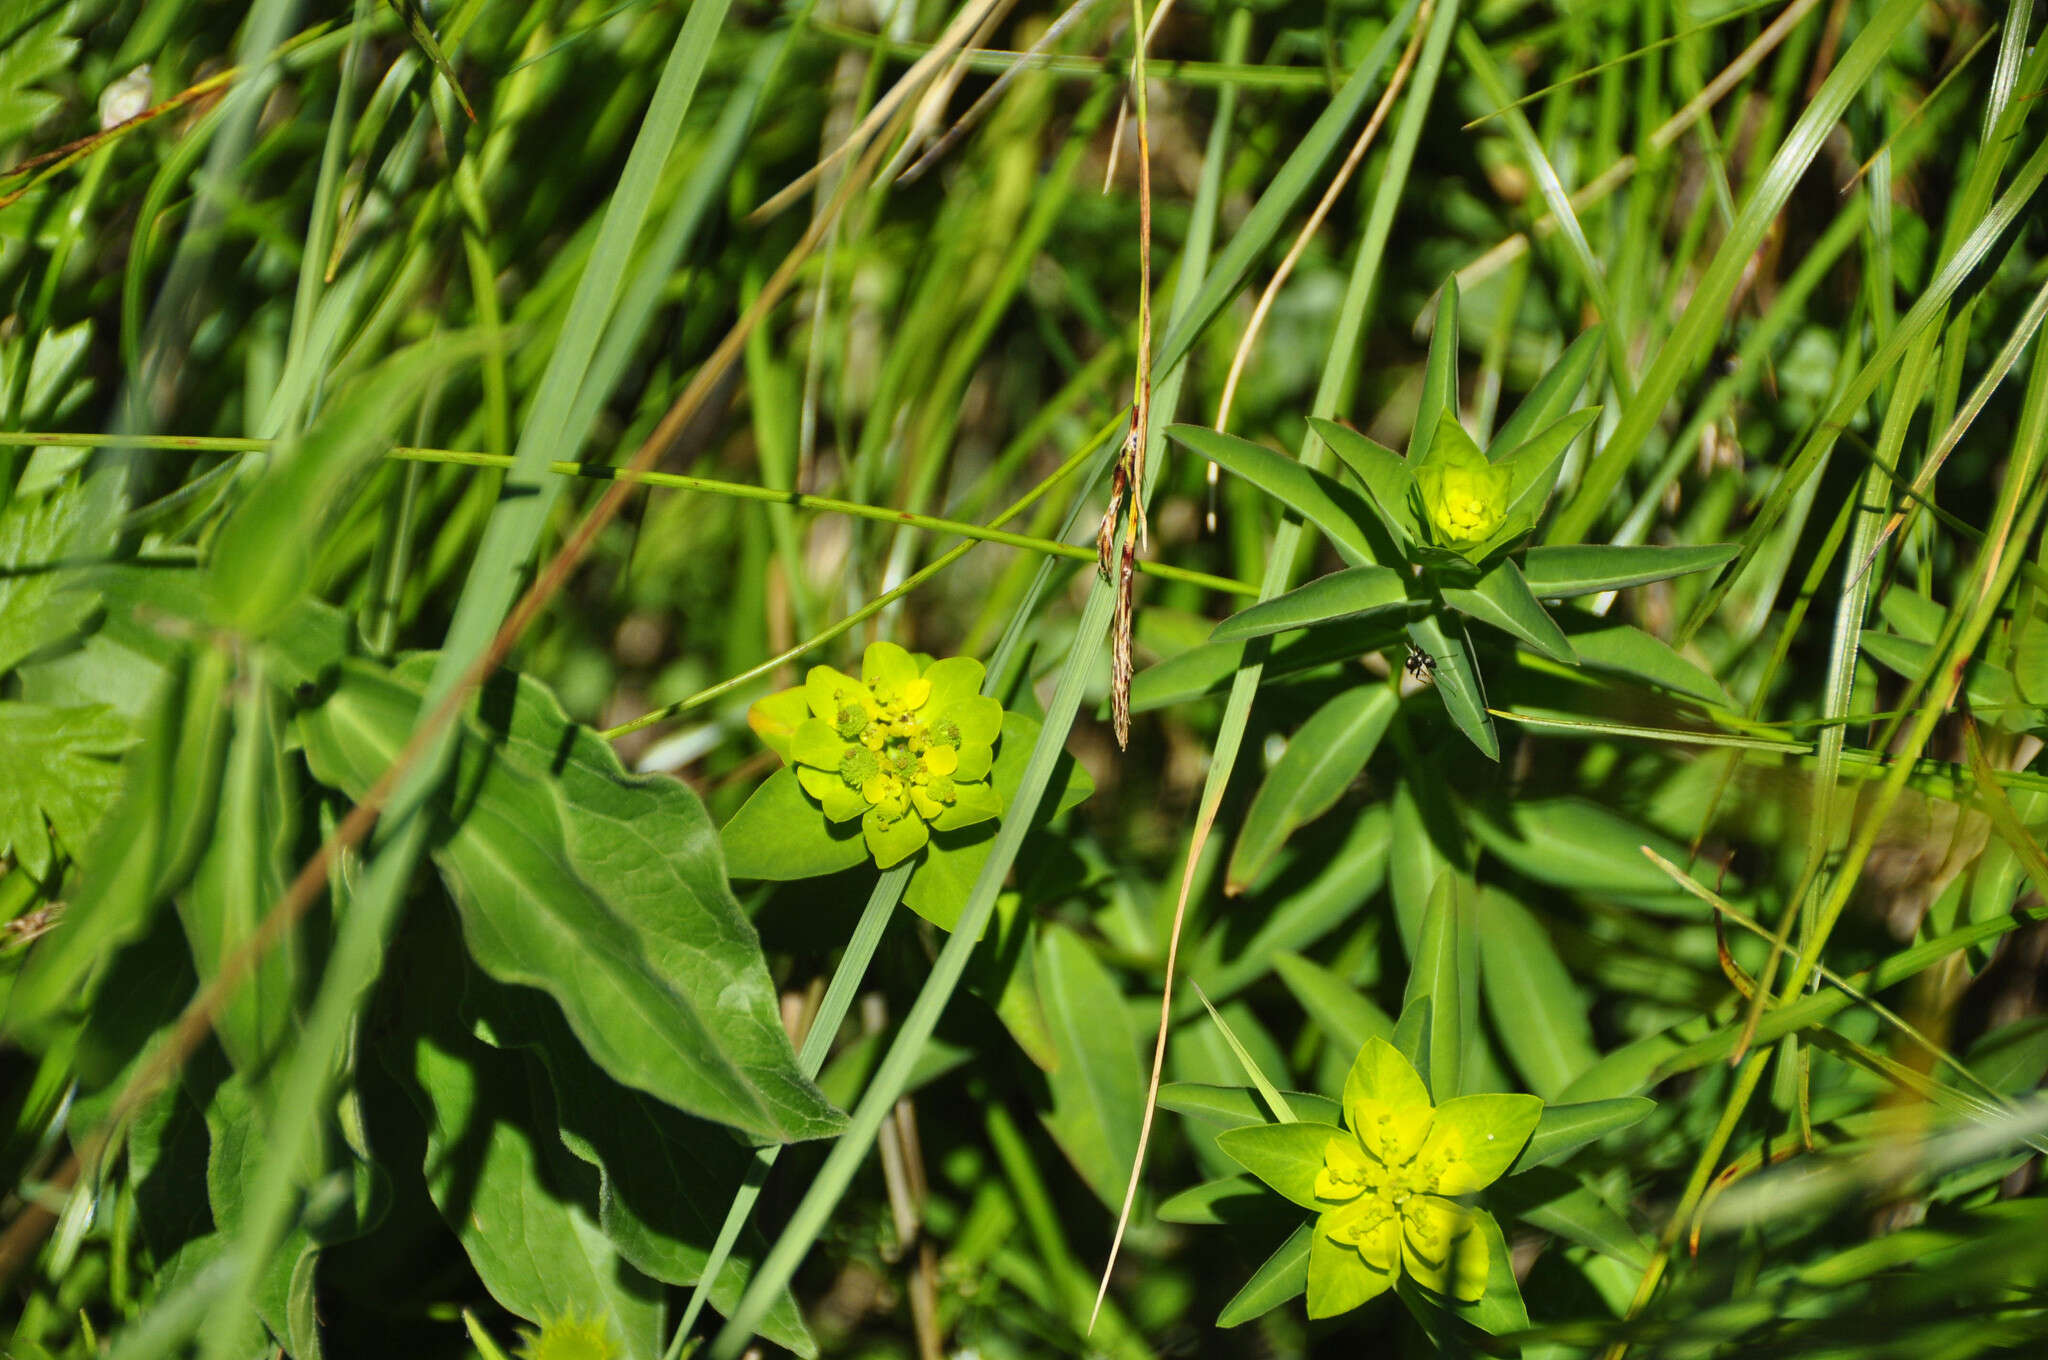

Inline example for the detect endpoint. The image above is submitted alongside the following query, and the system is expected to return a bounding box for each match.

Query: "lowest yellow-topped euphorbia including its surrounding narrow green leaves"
[1159,870,1653,1333]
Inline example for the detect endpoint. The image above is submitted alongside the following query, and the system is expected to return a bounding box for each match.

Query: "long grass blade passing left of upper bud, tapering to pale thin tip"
[1096,0,1458,1309]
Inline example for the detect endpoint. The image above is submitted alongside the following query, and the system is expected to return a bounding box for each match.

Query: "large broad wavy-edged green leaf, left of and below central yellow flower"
[301,655,842,1141]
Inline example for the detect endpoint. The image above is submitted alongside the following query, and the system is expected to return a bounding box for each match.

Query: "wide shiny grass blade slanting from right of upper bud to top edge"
[1544,0,1921,543]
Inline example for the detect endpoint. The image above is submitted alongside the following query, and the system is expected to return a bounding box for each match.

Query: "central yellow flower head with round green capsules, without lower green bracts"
[748,641,1004,868]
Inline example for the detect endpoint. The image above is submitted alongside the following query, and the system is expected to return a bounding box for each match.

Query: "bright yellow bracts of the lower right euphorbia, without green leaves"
[1309,1038,1542,1317]
